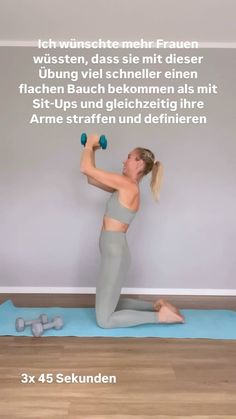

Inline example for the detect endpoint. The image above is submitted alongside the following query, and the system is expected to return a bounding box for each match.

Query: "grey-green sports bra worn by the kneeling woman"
[104,191,137,224]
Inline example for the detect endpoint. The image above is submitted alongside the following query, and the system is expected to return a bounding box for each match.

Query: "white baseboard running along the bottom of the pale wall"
[0,287,236,296]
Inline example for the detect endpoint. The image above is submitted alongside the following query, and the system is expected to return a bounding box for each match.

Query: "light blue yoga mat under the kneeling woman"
[0,300,236,340]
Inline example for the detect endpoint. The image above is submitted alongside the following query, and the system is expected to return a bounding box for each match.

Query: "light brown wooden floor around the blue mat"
[0,295,236,419]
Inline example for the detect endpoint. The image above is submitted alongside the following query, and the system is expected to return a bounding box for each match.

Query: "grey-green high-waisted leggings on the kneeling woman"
[95,230,158,328]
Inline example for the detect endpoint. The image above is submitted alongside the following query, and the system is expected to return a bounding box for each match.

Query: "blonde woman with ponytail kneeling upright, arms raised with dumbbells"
[80,135,184,328]
